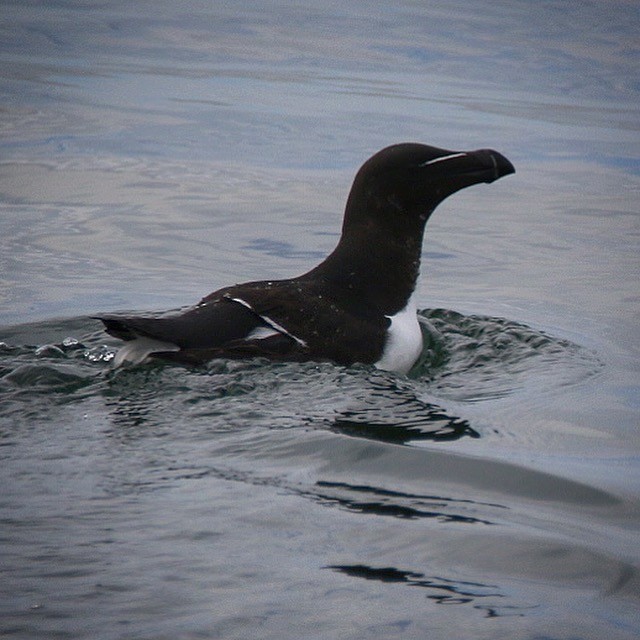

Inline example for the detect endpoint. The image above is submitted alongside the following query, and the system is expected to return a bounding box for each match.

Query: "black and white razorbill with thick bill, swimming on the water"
[99,143,515,370]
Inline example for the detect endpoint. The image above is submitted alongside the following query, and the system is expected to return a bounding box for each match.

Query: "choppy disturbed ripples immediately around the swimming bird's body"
[0,309,601,444]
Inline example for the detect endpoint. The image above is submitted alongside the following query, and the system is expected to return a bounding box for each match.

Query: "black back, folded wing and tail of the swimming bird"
[99,279,389,365]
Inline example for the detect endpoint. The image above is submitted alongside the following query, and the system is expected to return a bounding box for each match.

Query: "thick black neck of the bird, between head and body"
[307,227,422,315]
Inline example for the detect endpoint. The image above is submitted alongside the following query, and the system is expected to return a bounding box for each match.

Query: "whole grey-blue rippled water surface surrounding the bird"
[0,0,640,639]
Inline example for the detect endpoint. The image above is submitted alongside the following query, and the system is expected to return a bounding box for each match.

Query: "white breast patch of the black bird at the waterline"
[375,296,422,373]
